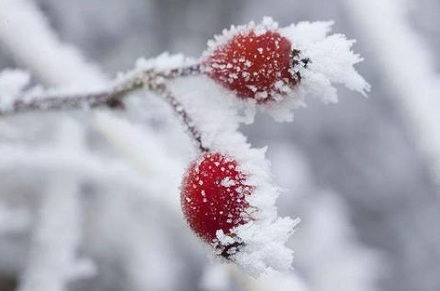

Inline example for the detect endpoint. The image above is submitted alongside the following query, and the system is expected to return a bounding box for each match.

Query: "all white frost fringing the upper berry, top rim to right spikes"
[202,17,370,123]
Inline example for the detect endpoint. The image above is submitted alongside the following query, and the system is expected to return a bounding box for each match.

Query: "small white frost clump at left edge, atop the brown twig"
[0,69,30,111]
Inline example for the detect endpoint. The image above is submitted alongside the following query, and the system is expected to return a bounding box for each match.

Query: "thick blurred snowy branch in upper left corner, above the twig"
[0,0,106,90]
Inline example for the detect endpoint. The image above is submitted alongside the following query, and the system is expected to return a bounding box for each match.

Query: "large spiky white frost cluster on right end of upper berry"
[274,21,370,121]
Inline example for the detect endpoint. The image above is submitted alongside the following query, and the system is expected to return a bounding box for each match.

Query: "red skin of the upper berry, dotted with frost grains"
[202,30,298,104]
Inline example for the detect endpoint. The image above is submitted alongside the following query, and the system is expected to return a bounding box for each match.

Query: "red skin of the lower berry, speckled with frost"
[181,153,252,243]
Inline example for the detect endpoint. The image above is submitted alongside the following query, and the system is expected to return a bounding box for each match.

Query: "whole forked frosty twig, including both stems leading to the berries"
[0,60,208,151]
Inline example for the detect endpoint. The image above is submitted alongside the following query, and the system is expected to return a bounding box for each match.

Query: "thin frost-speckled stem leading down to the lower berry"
[154,83,209,152]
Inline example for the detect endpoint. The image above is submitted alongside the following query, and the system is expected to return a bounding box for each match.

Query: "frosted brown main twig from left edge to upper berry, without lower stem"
[0,64,199,115]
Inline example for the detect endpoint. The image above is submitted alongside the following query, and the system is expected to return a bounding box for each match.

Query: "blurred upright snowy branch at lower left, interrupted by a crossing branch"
[18,120,96,291]
